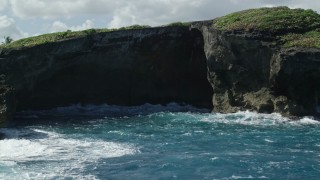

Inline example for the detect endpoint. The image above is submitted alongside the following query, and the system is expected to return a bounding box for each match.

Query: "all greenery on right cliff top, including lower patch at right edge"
[214,7,320,48]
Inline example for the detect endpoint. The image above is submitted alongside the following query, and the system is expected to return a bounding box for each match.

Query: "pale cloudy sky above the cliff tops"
[0,0,320,42]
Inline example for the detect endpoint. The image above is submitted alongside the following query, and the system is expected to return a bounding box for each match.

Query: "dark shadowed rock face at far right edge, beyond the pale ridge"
[270,48,320,116]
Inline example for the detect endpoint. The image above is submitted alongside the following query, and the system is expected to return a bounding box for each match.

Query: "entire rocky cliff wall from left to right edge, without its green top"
[0,8,320,127]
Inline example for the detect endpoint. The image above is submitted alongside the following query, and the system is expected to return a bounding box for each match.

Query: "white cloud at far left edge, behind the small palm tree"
[0,15,28,39]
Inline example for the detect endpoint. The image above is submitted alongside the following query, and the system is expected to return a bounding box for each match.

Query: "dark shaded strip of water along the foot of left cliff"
[11,103,211,128]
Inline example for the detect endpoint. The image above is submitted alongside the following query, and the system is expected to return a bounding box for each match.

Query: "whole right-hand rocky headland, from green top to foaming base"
[192,7,320,117]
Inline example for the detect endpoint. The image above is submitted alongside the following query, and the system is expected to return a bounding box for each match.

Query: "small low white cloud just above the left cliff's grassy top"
[50,20,94,32]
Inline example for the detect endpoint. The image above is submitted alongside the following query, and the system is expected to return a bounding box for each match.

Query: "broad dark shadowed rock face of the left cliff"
[0,27,212,126]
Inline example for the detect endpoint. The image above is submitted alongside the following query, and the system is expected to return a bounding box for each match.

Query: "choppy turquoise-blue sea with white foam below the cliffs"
[0,103,320,180]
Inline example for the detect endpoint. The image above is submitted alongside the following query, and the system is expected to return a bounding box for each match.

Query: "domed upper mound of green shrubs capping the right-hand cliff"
[214,7,320,34]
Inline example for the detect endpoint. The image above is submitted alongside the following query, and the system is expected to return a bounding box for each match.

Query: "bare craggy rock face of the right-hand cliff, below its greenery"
[193,21,320,116]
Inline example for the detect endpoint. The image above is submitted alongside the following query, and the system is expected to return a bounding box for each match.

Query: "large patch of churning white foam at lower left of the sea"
[0,129,139,179]
